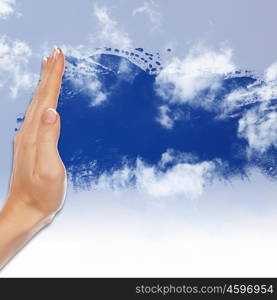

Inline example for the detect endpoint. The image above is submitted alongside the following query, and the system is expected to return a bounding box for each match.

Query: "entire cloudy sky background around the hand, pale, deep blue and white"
[0,0,277,276]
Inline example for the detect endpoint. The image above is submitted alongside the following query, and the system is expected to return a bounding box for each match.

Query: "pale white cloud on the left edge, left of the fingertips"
[0,36,38,98]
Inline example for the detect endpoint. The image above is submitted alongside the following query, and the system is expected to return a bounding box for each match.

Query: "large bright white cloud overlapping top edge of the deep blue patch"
[156,47,235,108]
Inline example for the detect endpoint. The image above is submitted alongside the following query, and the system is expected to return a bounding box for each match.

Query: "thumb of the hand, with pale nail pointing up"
[35,108,61,177]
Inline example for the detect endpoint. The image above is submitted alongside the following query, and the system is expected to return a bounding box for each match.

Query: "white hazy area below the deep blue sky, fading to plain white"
[1,172,277,277]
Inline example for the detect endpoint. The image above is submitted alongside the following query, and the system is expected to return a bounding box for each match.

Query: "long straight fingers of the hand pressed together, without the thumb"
[21,48,64,139]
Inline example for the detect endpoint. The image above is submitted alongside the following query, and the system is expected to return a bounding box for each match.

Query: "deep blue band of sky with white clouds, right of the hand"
[56,48,277,186]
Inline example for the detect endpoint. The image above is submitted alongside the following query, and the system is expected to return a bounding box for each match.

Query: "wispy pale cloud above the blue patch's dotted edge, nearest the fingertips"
[91,5,132,49]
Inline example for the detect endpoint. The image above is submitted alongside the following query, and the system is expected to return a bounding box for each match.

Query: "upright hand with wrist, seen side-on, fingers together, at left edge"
[0,48,66,266]
